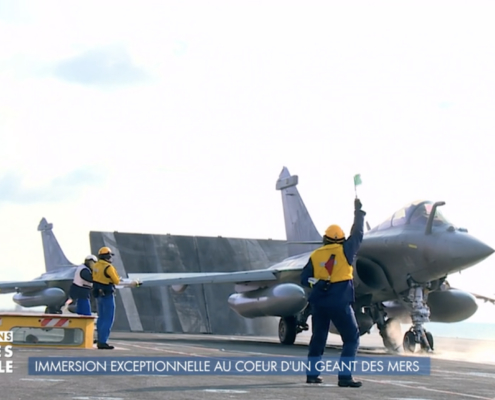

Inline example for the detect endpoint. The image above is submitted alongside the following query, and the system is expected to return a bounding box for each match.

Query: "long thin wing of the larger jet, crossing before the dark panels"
[128,269,279,286]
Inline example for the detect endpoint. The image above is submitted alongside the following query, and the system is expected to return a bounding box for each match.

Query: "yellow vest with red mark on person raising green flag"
[310,244,353,283]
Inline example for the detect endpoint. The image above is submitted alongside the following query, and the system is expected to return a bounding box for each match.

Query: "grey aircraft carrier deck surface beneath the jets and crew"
[4,332,495,400]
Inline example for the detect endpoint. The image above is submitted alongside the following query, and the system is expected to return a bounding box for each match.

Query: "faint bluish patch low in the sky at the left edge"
[0,168,103,204]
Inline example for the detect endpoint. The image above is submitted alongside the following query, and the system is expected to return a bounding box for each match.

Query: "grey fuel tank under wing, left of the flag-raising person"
[228,283,307,318]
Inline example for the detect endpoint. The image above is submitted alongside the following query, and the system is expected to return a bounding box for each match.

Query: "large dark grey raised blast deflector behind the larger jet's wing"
[90,232,287,335]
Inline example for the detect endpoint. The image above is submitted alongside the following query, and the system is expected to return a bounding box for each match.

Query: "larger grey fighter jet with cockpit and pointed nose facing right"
[129,167,494,352]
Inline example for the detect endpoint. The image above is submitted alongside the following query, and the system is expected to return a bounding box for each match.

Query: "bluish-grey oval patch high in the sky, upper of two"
[54,47,148,86]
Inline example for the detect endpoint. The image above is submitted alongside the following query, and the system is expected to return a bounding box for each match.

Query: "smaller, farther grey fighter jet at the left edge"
[0,218,135,314]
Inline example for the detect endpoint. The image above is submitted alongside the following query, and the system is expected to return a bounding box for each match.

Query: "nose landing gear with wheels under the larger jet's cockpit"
[403,278,433,353]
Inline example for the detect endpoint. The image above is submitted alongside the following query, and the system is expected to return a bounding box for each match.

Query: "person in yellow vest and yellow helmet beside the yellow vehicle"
[93,247,120,350]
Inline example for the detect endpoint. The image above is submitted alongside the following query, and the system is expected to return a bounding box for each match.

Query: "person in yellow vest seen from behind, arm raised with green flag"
[301,198,366,387]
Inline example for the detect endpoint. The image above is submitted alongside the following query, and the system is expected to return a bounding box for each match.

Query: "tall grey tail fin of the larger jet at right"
[276,167,322,256]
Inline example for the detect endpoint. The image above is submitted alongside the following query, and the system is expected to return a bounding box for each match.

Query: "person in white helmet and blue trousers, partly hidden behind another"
[69,254,98,315]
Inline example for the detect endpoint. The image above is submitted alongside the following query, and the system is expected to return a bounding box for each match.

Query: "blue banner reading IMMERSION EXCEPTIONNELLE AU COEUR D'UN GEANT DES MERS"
[28,356,430,375]
